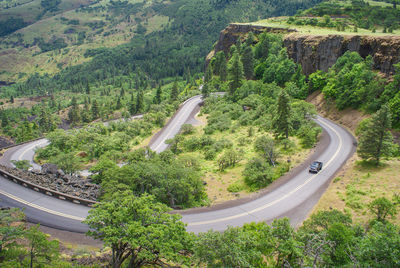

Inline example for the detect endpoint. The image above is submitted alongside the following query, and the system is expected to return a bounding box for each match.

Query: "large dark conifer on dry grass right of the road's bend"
[357,105,393,165]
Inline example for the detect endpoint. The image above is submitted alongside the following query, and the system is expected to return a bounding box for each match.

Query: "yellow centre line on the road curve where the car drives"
[188,120,342,226]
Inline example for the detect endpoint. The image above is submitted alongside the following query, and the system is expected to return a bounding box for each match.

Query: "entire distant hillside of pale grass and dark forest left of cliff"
[0,0,321,85]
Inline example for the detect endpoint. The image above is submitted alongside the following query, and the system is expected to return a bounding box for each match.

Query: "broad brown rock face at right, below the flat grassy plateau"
[284,33,400,76]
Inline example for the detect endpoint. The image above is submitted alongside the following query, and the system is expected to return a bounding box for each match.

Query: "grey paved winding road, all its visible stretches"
[0,96,355,233]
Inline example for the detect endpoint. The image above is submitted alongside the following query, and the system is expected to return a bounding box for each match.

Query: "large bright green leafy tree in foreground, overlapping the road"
[85,192,192,267]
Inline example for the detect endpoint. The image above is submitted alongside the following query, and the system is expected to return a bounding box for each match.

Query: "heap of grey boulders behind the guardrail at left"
[0,165,100,201]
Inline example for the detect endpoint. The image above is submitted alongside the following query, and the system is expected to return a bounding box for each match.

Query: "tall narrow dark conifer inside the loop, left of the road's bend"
[273,90,292,139]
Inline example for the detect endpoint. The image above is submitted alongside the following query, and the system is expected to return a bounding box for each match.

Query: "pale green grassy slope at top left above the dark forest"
[0,0,169,81]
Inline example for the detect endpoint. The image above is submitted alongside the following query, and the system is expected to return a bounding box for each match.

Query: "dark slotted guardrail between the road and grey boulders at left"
[0,169,98,207]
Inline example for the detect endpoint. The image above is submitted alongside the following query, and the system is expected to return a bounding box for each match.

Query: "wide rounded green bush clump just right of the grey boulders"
[96,150,206,208]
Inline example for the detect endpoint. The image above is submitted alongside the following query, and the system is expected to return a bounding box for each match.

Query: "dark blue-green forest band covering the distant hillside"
[1,0,320,97]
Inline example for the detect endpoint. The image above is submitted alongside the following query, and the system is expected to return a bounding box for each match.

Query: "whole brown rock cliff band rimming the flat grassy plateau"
[206,24,400,75]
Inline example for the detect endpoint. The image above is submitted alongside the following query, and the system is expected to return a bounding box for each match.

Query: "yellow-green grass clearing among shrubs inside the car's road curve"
[180,115,310,204]
